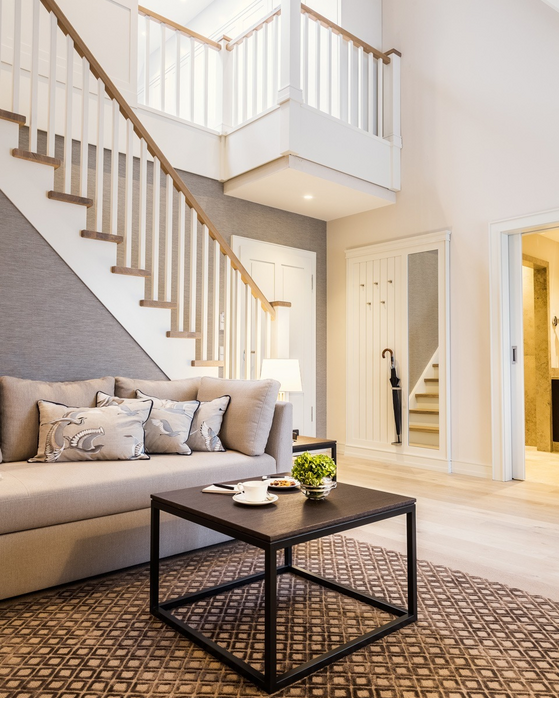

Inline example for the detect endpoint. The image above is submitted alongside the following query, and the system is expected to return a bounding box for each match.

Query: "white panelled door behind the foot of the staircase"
[232,235,316,437]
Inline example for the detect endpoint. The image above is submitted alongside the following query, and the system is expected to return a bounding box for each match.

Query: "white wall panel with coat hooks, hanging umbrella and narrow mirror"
[346,232,450,470]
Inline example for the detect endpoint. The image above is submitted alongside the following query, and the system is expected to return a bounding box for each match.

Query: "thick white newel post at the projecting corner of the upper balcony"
[278,0,303,105]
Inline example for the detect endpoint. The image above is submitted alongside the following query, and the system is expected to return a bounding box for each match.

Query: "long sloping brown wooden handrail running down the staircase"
[41,0,276,318]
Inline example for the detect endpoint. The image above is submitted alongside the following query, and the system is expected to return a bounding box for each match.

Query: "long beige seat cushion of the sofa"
[0,451,276,542]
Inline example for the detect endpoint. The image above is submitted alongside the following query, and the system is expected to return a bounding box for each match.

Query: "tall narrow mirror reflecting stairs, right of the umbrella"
[408,250,440,450]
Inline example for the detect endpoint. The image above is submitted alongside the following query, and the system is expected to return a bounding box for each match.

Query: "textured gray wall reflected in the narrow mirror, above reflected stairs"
[408,250,439,392]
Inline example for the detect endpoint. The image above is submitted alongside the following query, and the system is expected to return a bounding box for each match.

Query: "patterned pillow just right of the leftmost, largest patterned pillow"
[135,390,200,455]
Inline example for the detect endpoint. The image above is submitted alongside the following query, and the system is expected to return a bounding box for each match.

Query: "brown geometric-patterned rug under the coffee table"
[0,535,559,698]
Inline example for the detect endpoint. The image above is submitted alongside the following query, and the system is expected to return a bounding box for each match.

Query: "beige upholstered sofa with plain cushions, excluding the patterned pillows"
[0,377,292,598]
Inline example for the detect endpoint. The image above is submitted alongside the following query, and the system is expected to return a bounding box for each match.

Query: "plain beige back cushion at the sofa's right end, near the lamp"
[198,377,280,455]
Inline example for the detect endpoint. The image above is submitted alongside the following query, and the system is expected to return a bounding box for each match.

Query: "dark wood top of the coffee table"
[151,483,415,544]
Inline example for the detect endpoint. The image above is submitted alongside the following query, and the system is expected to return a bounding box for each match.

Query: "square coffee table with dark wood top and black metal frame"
[150,478,417,693]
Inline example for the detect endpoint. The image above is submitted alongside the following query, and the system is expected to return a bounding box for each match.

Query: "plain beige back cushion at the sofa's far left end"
[0,375,115,463]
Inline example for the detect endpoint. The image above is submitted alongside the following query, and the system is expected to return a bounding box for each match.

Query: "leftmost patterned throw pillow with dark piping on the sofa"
[29,400,152,462]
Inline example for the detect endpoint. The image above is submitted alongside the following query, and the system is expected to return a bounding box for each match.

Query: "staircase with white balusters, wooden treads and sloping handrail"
[0,0,275,378]
